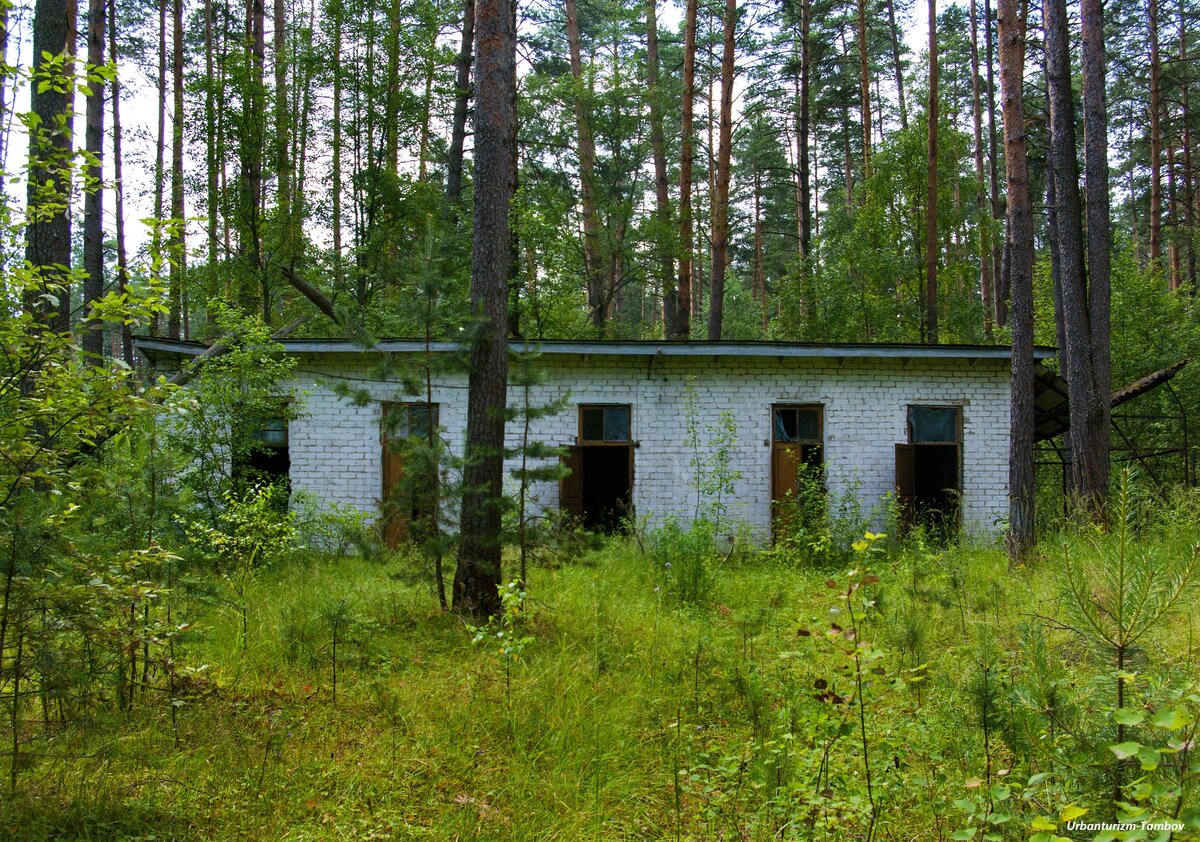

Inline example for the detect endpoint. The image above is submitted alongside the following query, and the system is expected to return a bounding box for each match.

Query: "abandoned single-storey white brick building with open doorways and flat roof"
[138,338,1054,541]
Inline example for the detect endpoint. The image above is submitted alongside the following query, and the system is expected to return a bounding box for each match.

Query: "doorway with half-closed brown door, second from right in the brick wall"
[770,405,824,534]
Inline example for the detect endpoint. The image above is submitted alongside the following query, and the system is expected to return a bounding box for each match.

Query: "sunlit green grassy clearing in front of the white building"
[0,527,1200,840]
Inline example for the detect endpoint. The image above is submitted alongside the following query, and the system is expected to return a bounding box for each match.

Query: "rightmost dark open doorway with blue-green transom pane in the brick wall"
[896,405,962,534]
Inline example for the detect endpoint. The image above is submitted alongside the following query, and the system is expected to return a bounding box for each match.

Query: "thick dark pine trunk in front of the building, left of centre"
[454,0,516,617]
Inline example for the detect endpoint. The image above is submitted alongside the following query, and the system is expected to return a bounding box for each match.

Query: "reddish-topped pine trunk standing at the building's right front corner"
[997,0,1034,564]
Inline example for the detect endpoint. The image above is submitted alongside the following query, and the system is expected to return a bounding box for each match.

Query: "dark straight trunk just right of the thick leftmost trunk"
[82,0,106,362]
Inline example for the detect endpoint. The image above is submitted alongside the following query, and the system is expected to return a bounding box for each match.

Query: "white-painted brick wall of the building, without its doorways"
[289,354,1009,535]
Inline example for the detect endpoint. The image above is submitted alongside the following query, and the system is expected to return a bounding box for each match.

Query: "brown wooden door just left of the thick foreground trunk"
[380,402,438,549]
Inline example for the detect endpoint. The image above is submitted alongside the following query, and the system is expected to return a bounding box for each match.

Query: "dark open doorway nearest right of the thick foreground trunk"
[559,404,634,533]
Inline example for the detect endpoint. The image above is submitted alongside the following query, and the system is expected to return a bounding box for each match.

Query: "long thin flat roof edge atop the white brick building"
[134,337,1055,360]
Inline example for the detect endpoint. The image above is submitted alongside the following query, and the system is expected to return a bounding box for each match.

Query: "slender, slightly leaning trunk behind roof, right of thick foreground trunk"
[566,0,612,336]
